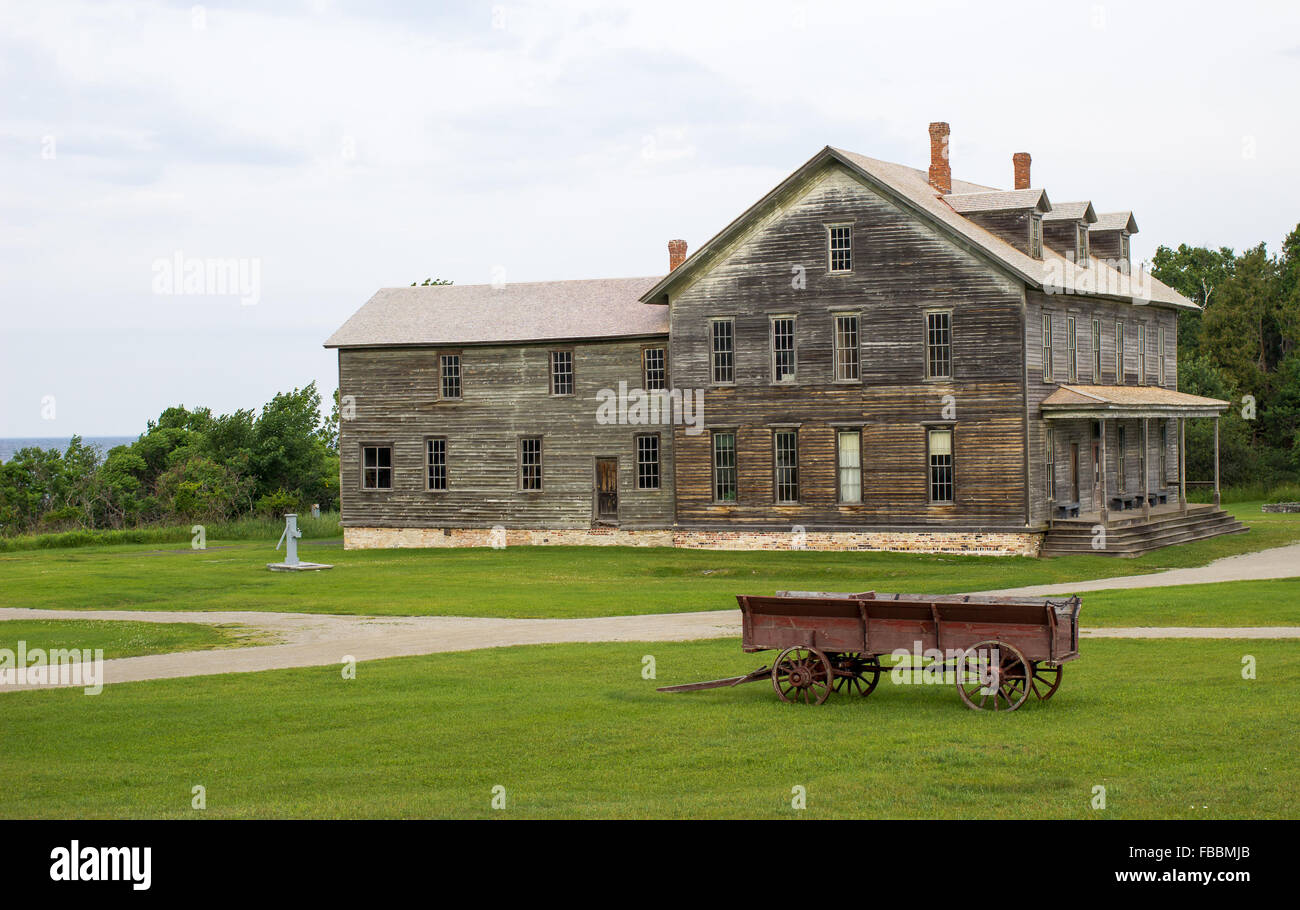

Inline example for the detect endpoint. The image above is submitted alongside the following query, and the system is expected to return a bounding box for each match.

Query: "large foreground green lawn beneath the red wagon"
[0,641,1300,818]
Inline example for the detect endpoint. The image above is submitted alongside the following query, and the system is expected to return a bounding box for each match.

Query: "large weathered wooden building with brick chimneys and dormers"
[326,124,1240,554]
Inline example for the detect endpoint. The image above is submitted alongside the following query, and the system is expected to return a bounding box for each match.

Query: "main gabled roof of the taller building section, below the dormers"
[641,146,1199,309]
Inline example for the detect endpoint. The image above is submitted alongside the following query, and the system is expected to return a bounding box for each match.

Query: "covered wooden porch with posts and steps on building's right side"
[1041,385,1243,555]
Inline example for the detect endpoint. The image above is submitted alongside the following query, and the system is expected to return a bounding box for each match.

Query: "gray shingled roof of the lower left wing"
[325,277,668,347]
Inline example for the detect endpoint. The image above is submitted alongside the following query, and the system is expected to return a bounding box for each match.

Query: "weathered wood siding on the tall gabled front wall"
[671,168,1026,529]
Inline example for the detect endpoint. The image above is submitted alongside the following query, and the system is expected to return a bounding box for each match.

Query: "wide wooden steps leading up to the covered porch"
[1041,506,1249,556]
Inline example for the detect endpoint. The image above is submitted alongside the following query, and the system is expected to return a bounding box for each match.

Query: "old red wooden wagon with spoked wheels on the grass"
[659,592,1080,711]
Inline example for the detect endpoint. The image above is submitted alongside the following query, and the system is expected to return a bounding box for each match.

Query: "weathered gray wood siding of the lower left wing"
[339,338,673,528]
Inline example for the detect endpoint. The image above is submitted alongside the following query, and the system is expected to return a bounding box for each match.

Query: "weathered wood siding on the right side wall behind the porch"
[1026,291,1178,525]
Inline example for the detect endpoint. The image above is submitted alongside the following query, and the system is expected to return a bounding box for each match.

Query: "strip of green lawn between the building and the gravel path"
[0,503,1300,620]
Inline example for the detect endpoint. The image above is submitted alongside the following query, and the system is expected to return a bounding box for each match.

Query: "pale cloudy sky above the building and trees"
[0,0,1300,437]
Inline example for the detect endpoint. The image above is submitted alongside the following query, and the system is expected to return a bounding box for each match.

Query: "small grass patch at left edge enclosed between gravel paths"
[0,619,274,660]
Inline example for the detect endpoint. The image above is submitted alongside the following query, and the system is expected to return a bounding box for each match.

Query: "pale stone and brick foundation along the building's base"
[343,528,1043,556]
